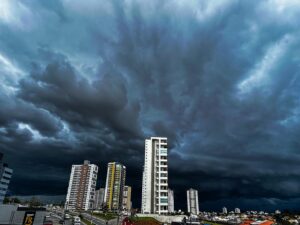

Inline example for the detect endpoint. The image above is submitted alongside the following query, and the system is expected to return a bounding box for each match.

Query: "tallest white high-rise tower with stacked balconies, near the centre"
[142,137,168,214]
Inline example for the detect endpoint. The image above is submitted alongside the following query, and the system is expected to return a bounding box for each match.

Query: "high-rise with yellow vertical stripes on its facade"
[104,162,126,211]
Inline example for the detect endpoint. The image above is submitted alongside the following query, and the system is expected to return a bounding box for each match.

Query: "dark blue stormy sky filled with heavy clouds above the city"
[0,0,300,210]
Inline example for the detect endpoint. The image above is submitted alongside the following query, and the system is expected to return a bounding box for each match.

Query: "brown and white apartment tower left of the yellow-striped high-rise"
[65,160,98,210]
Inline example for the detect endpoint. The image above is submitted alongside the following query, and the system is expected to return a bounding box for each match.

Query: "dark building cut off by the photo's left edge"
[0,152,13,204]
